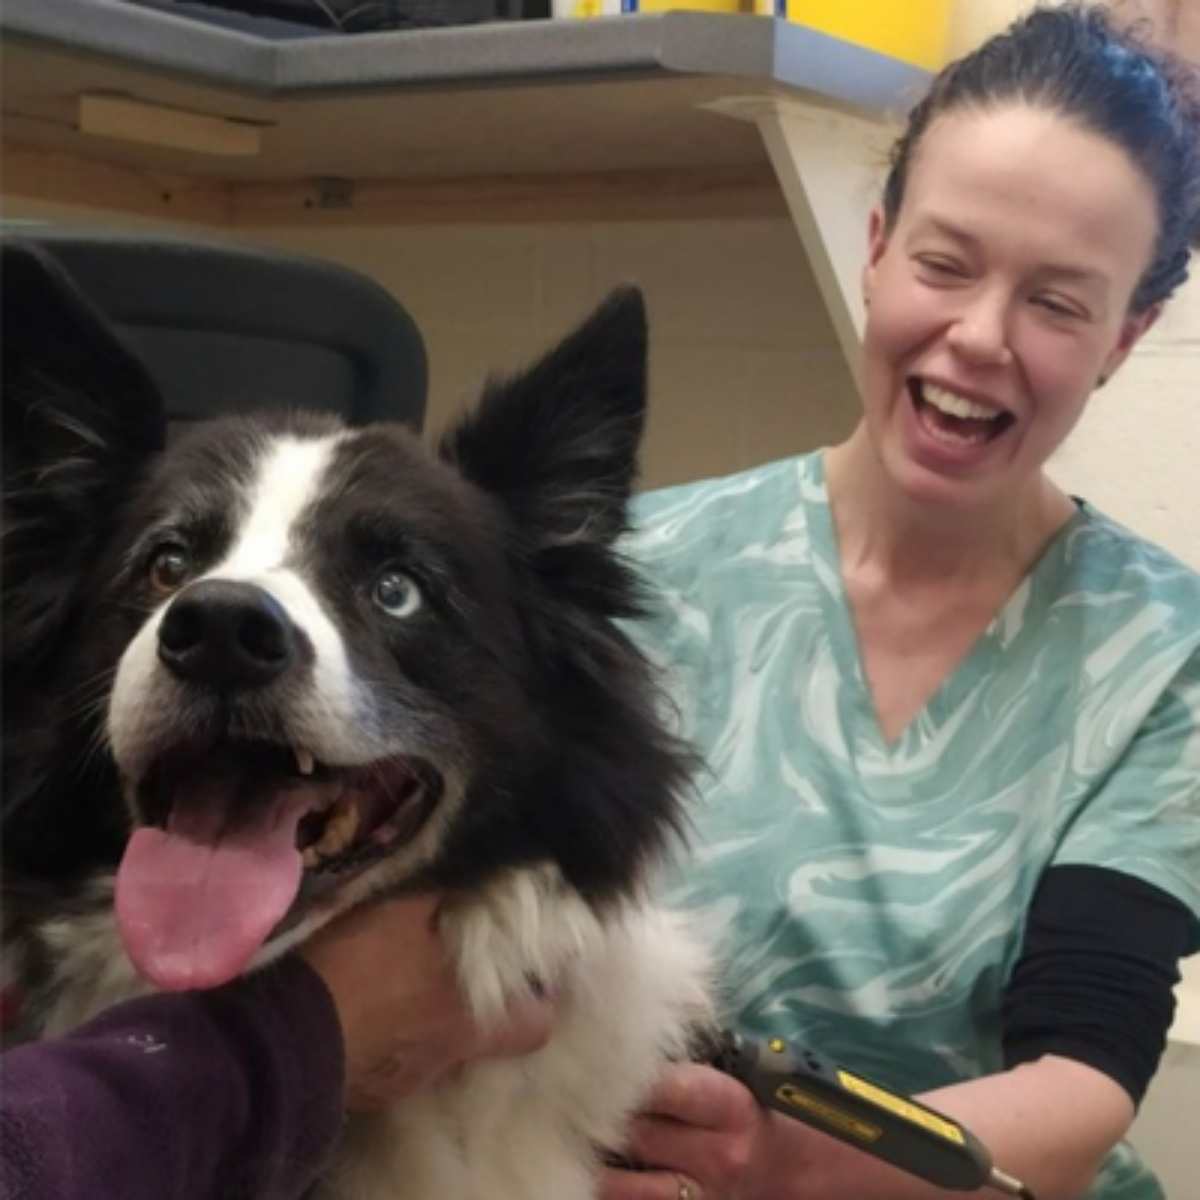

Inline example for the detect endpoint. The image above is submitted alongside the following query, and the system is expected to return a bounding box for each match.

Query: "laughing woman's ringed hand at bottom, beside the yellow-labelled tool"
[600,1063,769,1200]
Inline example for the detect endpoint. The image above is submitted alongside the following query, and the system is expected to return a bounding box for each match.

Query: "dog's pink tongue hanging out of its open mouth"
[116,790,312,991]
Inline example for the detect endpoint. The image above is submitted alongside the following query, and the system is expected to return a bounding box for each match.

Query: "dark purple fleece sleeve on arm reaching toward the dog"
[0,959,343,1200]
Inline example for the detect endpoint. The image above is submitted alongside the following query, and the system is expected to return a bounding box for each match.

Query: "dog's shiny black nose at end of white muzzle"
[158,580,296,691]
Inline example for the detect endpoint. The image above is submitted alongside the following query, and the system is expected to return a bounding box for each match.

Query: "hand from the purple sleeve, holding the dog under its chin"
[300,895,553,1111]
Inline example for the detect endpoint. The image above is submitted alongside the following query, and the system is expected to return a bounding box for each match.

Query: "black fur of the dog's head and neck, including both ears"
[2,240,691,1032]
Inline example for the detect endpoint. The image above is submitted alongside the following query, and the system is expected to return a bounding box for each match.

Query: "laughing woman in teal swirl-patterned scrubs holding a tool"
[605,5,1200,1200]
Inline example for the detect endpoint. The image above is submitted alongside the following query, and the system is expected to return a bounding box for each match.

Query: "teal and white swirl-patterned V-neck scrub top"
[625,454,1200,1200]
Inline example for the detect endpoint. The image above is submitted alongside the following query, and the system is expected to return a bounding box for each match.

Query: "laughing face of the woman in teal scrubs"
[863,103,1158,505]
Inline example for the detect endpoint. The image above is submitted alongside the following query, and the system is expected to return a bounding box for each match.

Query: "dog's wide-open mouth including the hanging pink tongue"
[116,742,442,990]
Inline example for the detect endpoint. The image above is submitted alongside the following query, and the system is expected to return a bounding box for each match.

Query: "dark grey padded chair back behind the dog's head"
[6,224,428,432]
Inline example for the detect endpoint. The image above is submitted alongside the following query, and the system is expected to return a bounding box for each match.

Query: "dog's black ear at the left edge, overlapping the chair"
[0,238,166,672]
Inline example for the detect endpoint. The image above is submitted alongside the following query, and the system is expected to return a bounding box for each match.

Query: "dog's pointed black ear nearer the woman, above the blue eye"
[440,288,646,553]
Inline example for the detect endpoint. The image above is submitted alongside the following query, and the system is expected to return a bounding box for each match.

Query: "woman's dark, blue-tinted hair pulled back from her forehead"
[883,4,1200,312]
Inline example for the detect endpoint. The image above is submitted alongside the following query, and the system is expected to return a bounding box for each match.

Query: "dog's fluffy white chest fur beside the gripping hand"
[323,871,710,1200]
